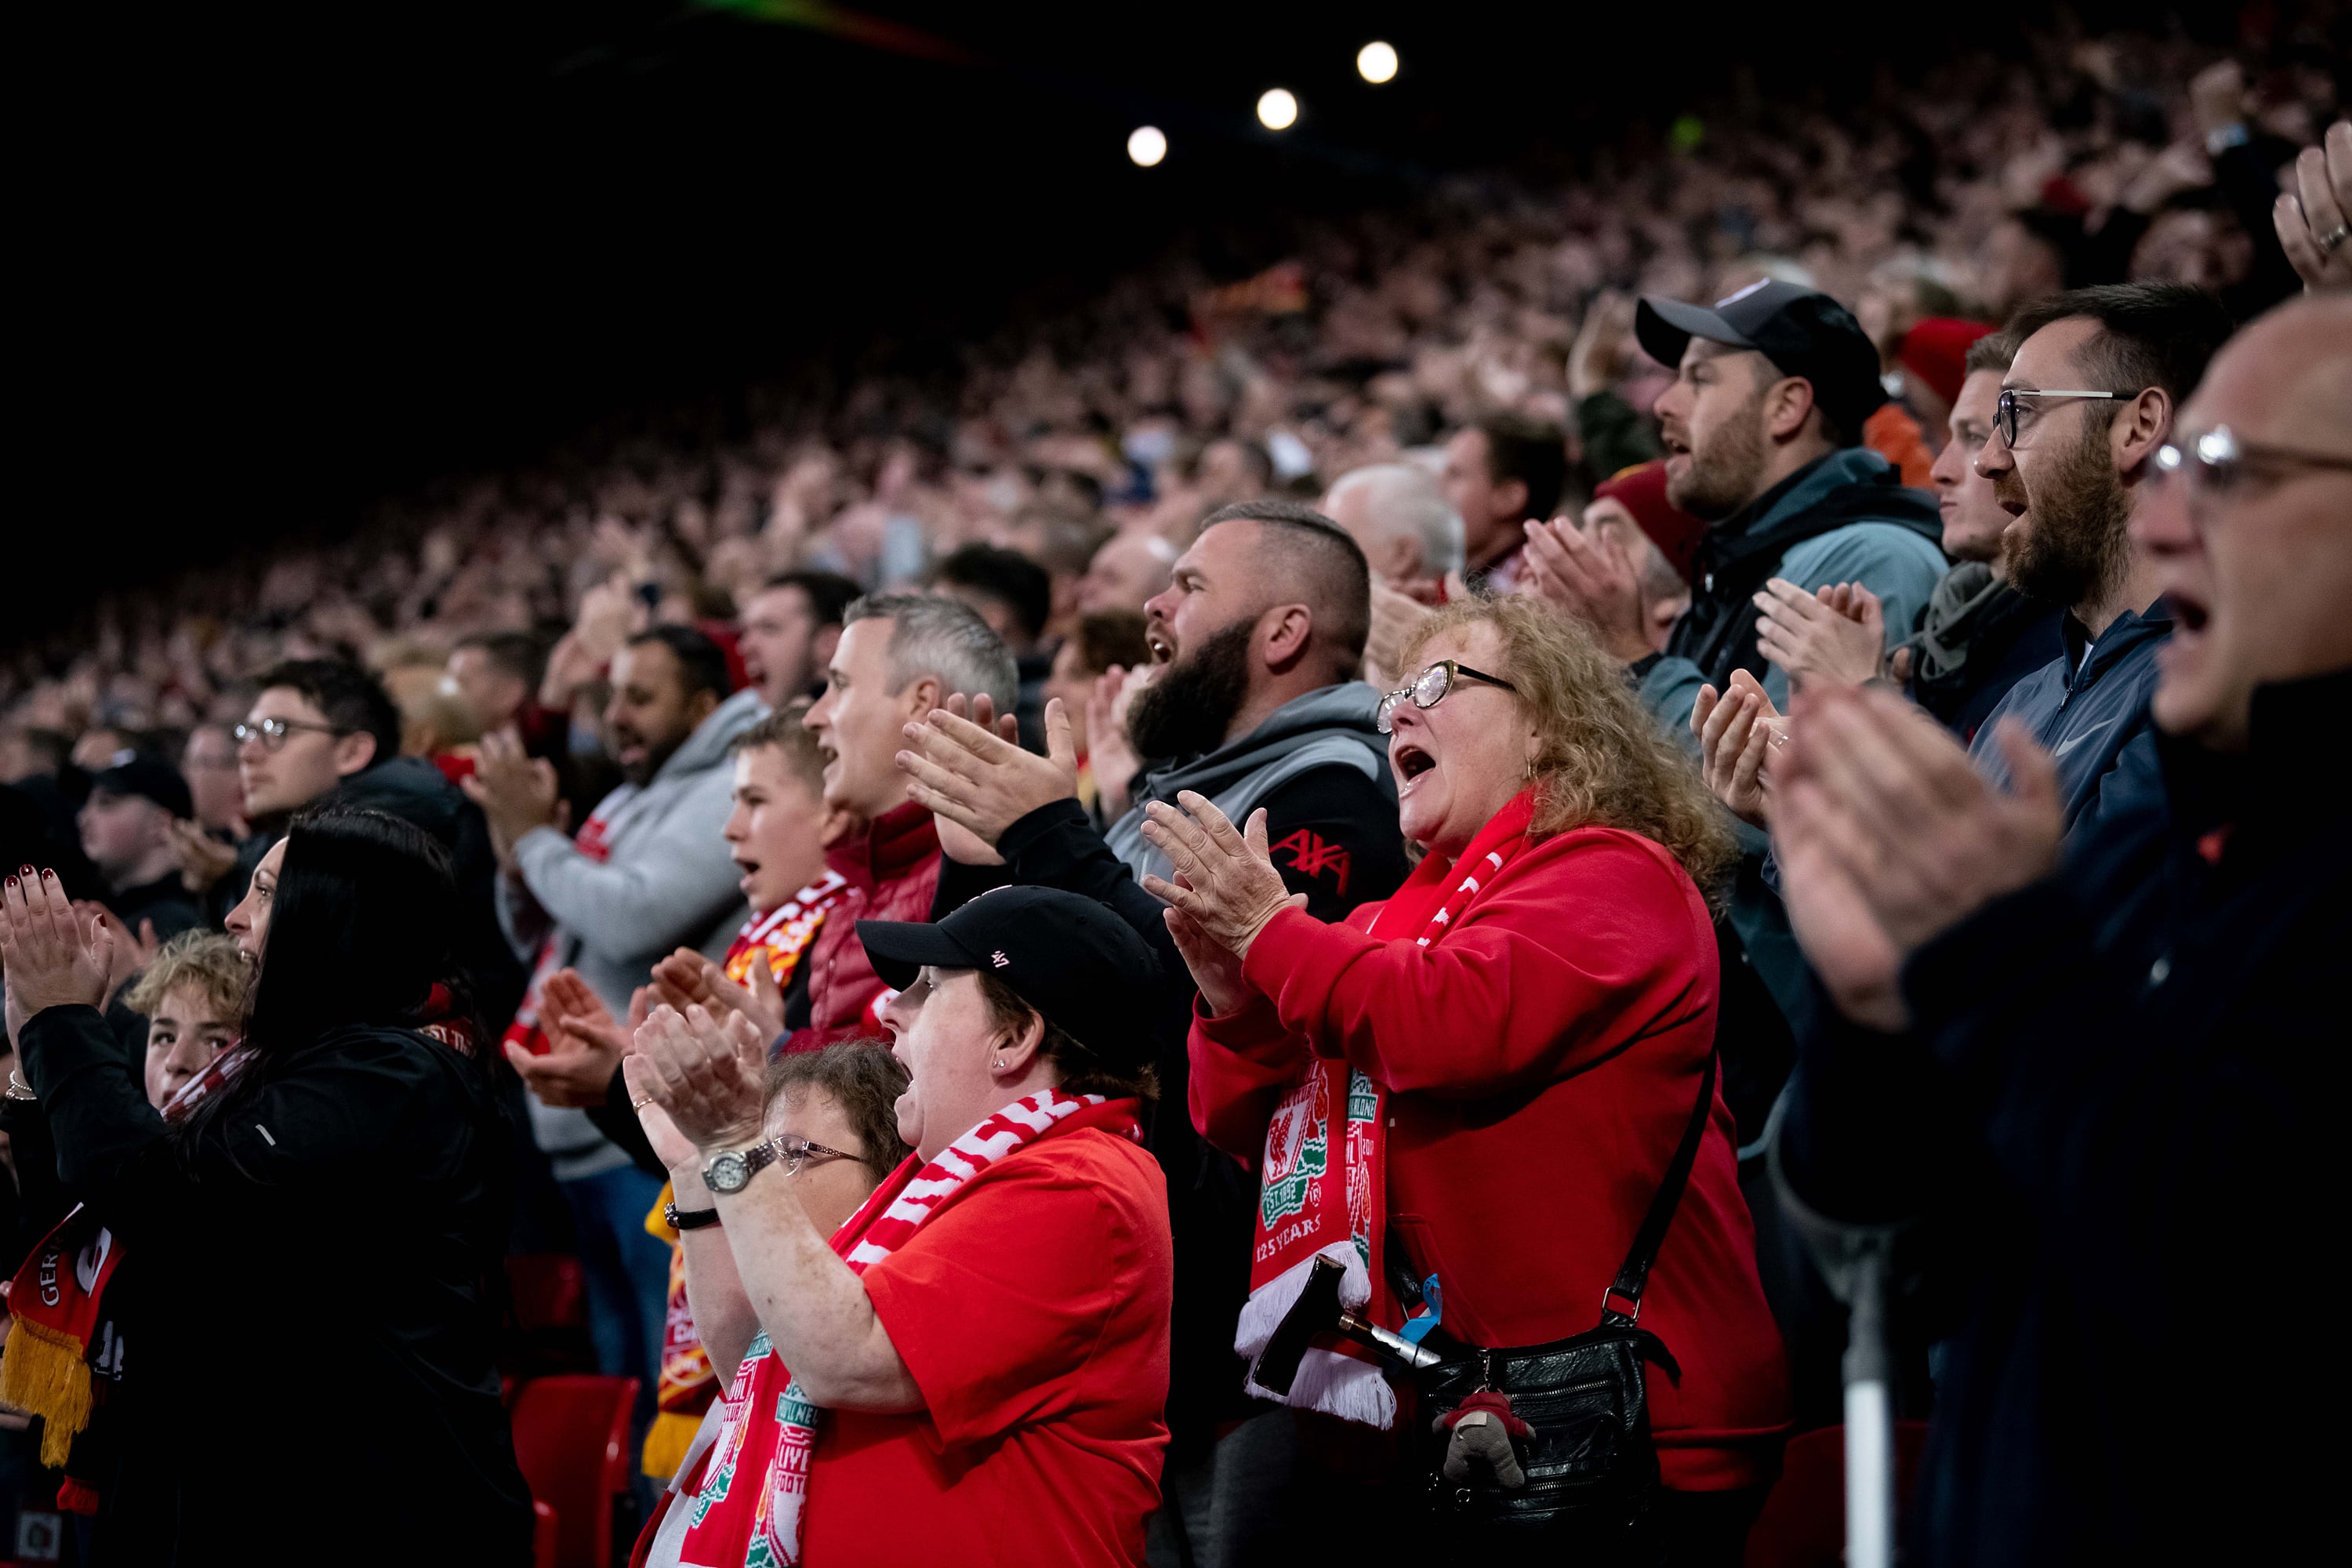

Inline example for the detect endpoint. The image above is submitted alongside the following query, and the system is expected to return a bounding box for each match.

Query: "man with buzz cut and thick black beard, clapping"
[880,501,1406,1561]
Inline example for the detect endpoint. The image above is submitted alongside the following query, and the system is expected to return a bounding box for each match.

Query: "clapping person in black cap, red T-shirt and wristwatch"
[626,888,1174,1563]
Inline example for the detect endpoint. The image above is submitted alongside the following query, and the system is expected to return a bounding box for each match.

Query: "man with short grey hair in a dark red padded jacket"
[783,593,1018,1051]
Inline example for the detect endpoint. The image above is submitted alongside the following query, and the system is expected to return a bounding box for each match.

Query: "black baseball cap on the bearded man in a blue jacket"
[1632,278,1886,442]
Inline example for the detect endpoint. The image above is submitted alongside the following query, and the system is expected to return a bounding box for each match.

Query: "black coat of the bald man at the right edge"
[1780,673,2352,1563]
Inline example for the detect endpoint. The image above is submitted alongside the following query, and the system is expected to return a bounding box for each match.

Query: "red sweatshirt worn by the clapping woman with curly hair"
[1190,827,1790,1490]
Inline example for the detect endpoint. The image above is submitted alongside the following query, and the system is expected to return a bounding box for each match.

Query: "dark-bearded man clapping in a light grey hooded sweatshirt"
[466,626,767,1389]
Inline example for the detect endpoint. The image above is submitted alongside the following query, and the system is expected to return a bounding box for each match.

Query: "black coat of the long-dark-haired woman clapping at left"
[21,1006,532,1568]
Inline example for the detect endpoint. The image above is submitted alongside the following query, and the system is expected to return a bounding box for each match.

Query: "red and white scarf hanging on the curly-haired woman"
[1232,789,1536,1429]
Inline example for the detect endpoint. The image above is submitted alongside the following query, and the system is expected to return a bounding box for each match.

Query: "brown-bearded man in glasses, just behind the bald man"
[1971,282,2232,832]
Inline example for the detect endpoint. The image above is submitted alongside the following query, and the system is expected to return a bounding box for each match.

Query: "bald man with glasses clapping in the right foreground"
[1773,278,2352,1566]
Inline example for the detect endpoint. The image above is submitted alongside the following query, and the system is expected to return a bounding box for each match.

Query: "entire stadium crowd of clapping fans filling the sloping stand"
[0,21,2352,1568]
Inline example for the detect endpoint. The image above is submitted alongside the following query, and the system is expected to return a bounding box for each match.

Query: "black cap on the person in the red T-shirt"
[858,886,1164,1062]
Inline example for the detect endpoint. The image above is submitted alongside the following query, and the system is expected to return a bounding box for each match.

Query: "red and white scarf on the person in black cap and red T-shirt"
[668,1088,1143,1568]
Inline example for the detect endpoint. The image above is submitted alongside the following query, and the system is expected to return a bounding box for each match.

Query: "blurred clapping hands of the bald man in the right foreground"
[1773,689,2065,1027]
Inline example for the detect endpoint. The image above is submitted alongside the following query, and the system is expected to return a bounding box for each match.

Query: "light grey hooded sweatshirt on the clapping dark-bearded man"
[499,689,767,1182]
